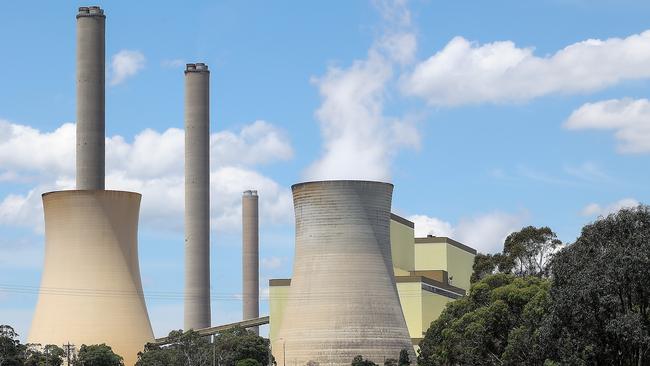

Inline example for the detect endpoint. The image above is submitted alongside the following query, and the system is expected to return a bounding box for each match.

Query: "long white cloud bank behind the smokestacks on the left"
[0,121,293,232]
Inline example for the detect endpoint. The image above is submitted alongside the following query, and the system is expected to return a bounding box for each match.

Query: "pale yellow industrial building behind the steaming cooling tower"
[269,214,476,345]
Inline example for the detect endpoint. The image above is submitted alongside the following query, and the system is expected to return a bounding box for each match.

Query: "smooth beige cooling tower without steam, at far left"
[28,190,153,365]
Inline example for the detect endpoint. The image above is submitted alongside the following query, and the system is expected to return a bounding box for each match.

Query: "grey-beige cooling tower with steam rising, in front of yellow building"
[272,181,415,365]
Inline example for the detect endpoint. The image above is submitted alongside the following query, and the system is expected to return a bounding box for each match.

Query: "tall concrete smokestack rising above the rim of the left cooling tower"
[77,6,106,190]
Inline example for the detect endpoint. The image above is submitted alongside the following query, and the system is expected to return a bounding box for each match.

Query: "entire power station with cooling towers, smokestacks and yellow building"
[28,6,476,365]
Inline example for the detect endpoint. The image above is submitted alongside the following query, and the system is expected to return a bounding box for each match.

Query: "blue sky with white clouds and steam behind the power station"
[0,0,650,336]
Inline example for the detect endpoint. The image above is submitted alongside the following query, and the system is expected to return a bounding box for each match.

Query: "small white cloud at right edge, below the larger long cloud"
[564,98,650,154]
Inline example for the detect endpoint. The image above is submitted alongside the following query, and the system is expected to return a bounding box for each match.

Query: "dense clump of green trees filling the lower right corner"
[418,206,650,366]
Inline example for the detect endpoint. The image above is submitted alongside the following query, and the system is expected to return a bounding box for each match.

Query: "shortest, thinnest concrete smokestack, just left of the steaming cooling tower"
[242,191,260,335]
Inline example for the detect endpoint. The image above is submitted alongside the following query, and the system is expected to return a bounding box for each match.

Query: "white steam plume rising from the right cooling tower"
[306,1,419,180]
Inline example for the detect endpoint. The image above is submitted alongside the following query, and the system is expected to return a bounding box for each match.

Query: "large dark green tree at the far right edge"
[544,206,650,365]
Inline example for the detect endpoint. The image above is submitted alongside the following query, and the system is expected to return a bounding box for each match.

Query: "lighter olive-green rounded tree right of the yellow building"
[418,273,550,366]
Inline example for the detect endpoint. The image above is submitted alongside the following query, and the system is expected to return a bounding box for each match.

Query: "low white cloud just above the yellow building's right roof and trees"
[408,211,527,253]
